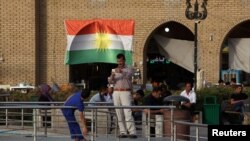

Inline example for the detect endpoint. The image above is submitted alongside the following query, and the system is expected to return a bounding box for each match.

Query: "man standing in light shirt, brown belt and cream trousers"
[108,54,137,138]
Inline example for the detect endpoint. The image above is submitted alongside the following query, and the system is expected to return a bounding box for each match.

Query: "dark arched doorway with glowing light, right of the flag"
[146,21,194,89]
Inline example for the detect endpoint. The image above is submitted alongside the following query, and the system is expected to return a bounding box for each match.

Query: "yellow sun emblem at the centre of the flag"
[95,33,111,51]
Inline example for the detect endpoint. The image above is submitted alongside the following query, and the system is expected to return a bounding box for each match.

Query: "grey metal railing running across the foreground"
[0,102,208,141]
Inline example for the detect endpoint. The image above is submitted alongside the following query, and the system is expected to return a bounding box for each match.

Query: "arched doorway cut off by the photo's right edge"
[220,20,250,85]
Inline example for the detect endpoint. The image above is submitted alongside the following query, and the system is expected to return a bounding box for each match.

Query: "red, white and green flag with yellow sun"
[65,19,134,65]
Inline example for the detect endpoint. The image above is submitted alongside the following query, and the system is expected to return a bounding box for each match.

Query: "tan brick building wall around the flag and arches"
[0,0,250,85]
